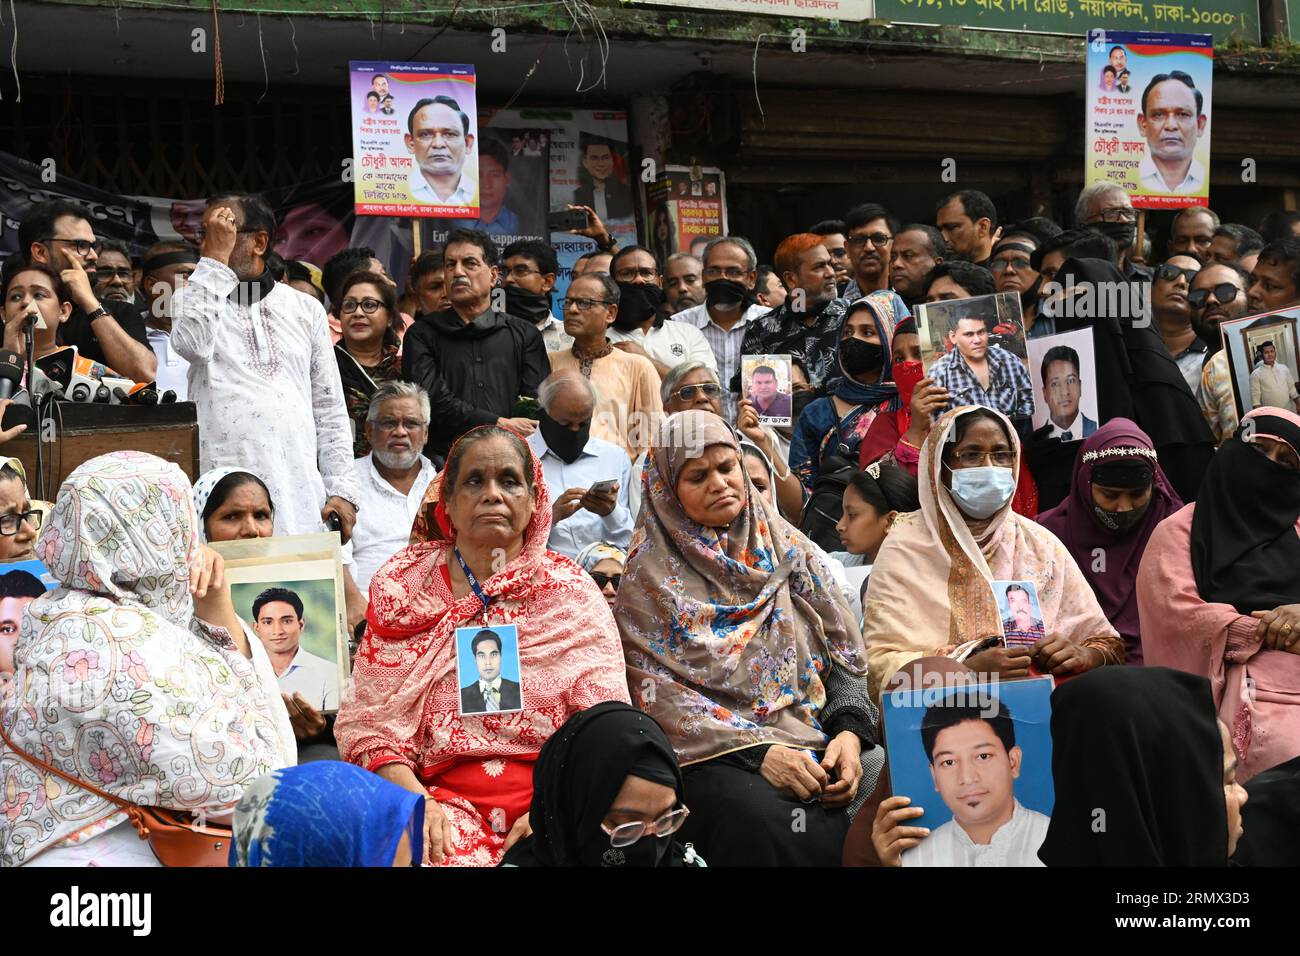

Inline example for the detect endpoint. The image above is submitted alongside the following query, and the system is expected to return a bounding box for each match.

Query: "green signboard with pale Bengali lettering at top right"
[876,0,1258,43]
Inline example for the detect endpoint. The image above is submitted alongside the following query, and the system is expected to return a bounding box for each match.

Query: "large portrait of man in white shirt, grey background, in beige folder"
[212,533,351,714]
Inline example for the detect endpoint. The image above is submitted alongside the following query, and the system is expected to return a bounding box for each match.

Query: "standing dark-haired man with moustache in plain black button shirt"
[402,229,550,454]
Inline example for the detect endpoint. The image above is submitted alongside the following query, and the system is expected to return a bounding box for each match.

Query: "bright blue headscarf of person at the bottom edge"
[230,761,424,866]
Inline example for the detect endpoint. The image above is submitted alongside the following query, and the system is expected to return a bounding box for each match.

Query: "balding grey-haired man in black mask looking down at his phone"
[528,369,632,558]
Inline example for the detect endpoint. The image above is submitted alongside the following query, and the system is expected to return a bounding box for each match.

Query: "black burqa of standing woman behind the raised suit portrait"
[1024,259,1216,511]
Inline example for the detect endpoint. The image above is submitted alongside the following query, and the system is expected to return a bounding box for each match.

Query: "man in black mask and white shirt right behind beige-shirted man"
[606,246,716,378]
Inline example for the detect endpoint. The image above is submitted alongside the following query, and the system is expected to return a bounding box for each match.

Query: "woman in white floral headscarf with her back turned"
[0,451,293,866]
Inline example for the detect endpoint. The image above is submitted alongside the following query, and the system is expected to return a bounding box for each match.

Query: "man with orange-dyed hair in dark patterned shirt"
[733,233,849,392]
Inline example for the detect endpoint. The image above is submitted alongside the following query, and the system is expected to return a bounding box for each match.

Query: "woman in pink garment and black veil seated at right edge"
[1138,407,1300,782]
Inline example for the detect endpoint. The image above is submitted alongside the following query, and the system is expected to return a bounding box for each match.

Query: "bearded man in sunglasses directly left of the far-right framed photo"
[1187,263,1251,444]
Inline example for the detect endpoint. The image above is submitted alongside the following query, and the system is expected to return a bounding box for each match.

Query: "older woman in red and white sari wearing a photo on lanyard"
[334,425,629,866]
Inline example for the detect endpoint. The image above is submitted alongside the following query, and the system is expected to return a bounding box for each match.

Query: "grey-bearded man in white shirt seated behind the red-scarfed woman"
[343,381,437,631]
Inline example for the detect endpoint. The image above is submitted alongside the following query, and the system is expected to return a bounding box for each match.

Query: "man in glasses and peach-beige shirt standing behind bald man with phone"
[549,273,663,458]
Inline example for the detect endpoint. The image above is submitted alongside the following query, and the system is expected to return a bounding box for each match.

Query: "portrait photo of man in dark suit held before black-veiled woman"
[1028,329,1097,441]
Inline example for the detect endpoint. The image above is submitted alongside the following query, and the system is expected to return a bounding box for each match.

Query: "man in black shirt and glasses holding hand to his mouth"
[18,199,157,382]
